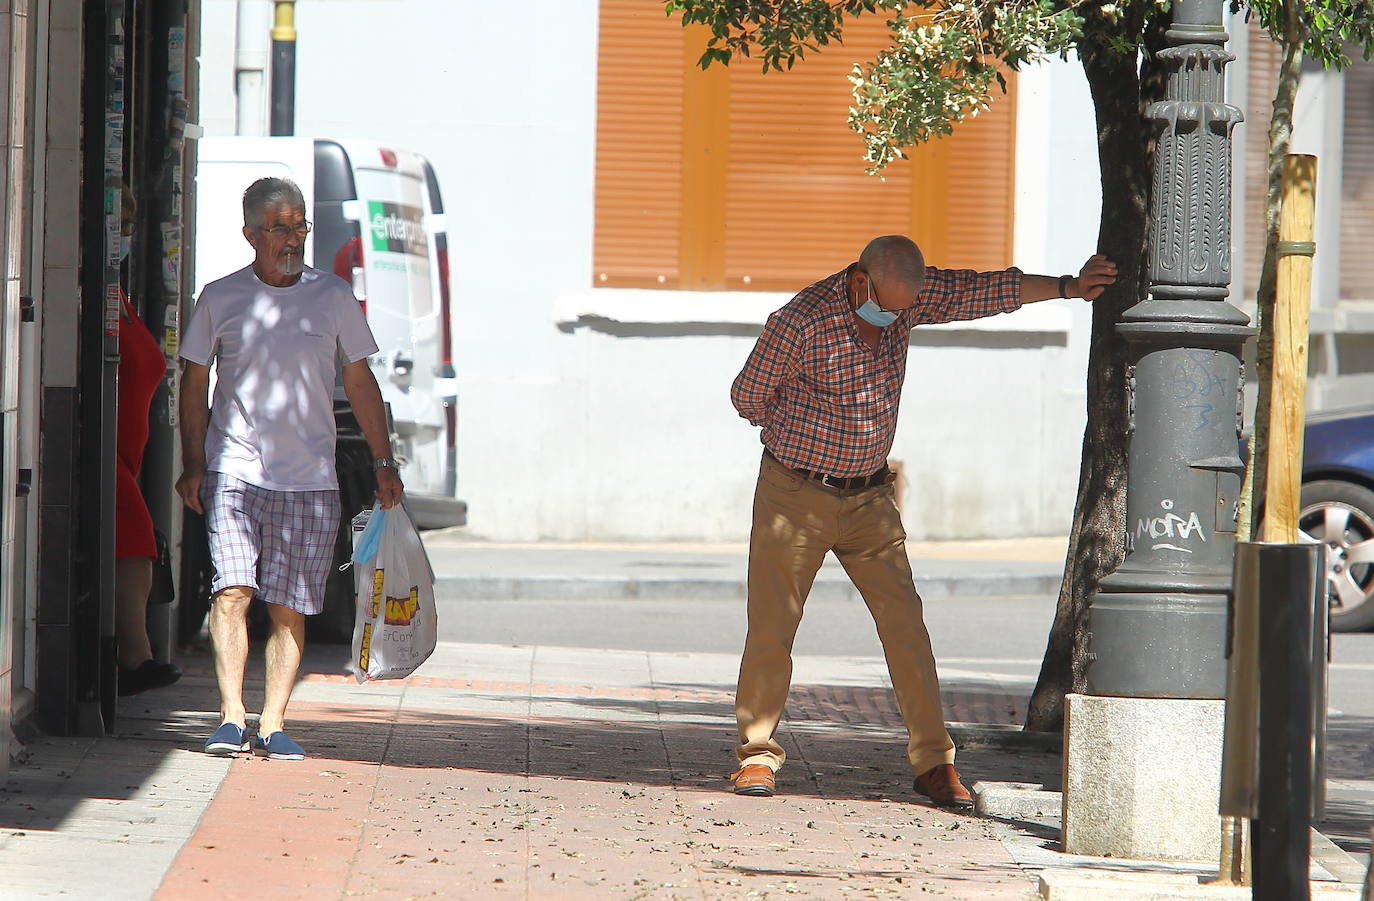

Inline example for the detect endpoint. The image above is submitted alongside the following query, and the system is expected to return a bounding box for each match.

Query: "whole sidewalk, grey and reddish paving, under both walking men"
[0,644,1363,901]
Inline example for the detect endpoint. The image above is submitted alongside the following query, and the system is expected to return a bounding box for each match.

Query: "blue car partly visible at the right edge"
[1297,408,1374,632]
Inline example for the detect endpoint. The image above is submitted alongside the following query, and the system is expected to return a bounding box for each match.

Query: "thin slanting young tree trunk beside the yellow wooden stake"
[1237,0,1307,541]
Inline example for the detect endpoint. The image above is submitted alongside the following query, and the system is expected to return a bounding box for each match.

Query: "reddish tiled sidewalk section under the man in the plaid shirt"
[131,646,1038,901]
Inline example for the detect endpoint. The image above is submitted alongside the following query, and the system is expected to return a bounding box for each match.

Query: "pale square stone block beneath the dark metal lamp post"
[1063,695,1226,863]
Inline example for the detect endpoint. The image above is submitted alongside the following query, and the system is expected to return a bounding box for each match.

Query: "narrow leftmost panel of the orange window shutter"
[596,0,683,287]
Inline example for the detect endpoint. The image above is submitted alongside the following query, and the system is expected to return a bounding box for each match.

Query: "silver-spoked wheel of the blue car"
[1297,479,1374,632]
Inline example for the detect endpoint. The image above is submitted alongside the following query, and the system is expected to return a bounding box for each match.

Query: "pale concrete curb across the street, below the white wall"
[434,573,1061,600]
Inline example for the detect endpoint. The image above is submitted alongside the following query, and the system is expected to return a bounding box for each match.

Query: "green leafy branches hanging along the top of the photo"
[664,0,1374,173]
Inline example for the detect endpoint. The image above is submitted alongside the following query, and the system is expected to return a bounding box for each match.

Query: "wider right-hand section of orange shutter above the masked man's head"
[725,16,1015,290]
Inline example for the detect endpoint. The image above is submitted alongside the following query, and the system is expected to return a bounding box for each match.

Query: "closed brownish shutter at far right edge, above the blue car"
[1341,63,1374,301]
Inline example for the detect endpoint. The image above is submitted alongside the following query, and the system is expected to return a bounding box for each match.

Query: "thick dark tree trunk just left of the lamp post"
[1025,16,1168,732]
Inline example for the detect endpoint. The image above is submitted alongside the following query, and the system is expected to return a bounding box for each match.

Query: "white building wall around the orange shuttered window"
[201,0,1098,541]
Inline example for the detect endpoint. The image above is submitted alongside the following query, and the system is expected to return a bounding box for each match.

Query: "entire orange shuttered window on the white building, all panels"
[594,0,1015,291]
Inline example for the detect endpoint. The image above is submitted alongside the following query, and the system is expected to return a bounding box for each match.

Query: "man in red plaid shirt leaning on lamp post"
[730,235,1116,809]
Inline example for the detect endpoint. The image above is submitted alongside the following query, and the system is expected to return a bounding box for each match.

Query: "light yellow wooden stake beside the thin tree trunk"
[1261,154,1316,544]
